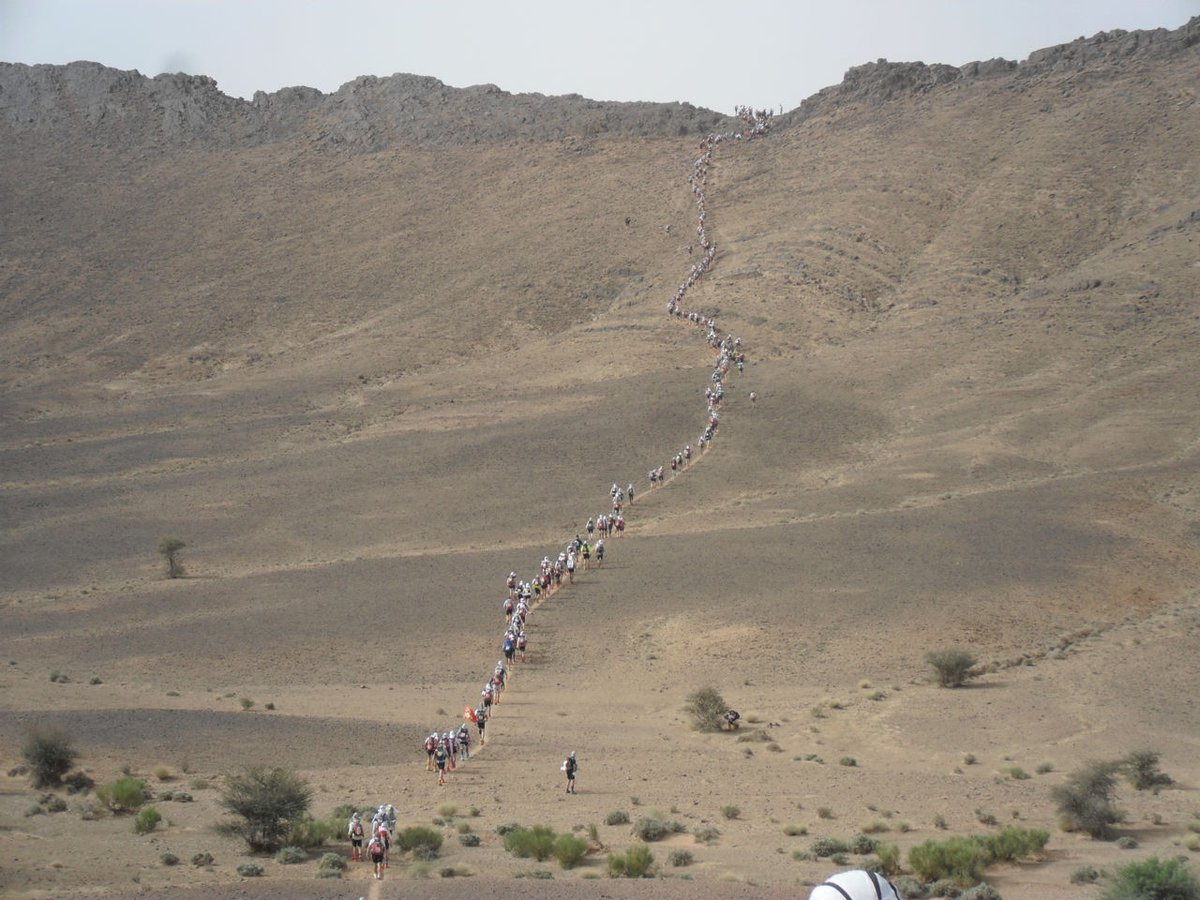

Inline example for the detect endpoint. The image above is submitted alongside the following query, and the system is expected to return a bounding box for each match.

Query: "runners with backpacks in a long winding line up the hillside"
[415,107,770,796]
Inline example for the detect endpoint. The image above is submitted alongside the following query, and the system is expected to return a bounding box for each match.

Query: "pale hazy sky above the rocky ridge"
[0,0,1200,112]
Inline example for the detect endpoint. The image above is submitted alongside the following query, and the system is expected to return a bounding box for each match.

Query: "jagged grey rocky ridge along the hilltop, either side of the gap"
[0,17,1200,152]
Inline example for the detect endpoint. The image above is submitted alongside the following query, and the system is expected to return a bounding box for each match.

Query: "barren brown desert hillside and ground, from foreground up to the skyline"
[0,19,1200,898]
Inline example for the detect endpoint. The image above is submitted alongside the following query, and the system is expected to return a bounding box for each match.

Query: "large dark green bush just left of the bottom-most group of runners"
[221,768,312,853]
